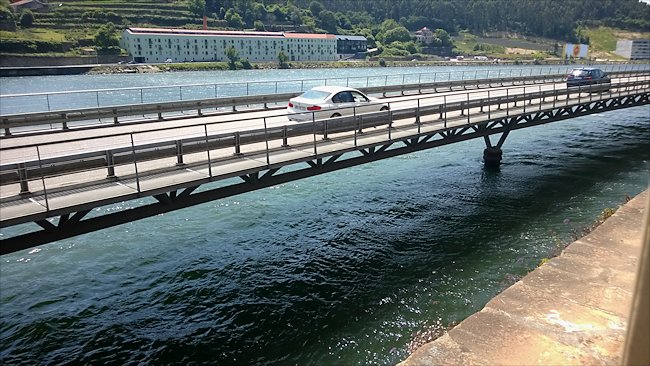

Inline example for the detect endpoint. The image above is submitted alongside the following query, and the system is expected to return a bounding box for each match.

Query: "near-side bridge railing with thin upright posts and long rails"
[0,78,650,227]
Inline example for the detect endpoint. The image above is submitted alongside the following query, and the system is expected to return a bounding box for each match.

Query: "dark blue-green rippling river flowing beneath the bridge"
[0,68,650,365]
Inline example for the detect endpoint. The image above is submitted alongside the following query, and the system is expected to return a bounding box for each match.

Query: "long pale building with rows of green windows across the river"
[120,28,337,62]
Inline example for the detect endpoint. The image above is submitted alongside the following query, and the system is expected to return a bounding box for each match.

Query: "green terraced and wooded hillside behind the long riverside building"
[0,0,650,57]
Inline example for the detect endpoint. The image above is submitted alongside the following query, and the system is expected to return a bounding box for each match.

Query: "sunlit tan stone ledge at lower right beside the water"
[400,191,649,366]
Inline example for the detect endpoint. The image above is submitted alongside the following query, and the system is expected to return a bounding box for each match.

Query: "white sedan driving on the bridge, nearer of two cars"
[287,86,388,121]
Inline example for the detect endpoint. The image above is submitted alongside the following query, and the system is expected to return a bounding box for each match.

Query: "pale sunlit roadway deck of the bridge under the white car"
[0,77,650,249]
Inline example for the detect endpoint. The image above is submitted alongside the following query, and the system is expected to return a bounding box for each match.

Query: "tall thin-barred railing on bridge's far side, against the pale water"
[0,64,648,114]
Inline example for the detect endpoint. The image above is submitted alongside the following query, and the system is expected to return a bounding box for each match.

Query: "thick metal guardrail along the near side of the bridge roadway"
[0,80,649,206]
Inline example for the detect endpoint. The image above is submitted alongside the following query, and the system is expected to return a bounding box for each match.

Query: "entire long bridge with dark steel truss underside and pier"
[0,70,650,254]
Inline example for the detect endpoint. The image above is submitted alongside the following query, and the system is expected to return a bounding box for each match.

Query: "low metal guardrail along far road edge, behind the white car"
[0,70,650,136]
